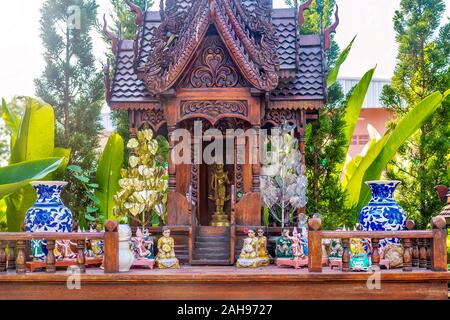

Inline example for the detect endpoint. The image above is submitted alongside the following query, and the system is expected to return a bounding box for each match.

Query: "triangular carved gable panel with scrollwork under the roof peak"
[178,34,249,88]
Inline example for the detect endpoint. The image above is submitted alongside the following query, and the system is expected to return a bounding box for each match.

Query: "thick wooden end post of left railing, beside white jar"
[103,220,119,273]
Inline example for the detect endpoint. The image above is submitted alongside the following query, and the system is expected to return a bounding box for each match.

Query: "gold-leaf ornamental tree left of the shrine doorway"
[114,129,168,228]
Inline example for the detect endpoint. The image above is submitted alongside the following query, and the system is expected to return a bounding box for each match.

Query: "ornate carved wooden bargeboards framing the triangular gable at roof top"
[137,0,279,94]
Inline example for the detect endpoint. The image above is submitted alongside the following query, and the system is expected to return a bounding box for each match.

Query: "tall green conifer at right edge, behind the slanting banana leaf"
[382,0,450,228]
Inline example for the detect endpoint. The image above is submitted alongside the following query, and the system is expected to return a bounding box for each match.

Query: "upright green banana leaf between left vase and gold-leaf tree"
[94,133,124,219]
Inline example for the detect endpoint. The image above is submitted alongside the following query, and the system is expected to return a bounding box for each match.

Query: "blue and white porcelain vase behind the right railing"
[359,180,406,249]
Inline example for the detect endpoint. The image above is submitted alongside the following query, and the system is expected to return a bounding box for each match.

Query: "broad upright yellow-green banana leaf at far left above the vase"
[2,97,70,231]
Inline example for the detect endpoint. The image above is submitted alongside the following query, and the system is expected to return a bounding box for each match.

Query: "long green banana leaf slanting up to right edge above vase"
[355,90,450,211]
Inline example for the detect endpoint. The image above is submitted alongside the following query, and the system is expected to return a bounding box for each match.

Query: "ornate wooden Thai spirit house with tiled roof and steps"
[104,0,338,265]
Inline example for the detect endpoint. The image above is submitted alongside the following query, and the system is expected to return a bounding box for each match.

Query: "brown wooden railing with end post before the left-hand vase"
[0,220,119,273]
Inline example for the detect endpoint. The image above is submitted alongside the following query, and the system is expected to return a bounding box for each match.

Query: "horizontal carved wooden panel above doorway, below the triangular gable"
[181,100,248,123]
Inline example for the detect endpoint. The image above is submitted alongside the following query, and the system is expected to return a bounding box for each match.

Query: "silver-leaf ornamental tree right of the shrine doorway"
[261,125,307,227]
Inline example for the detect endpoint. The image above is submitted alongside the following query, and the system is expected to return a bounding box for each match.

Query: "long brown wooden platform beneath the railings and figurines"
[0,266,450,300]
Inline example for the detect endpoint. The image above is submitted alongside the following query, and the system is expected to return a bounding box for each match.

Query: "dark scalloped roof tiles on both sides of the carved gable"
[111,4,325,103]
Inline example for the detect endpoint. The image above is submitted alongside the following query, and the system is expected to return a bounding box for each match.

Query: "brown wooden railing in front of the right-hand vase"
[308,217,447,272]
